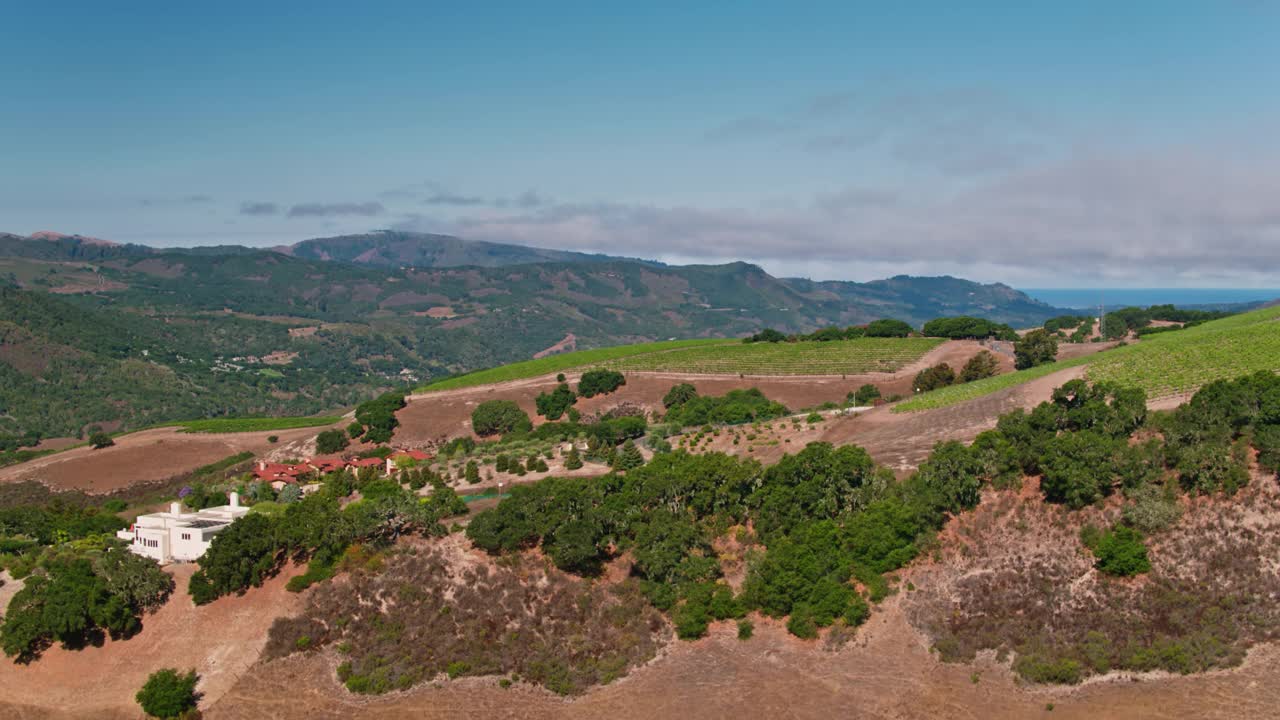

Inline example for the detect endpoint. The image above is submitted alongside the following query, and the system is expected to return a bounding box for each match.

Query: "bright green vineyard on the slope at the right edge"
[893,302,1280,413]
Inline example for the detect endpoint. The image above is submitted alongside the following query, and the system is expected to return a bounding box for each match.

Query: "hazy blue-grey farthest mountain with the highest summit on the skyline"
[278,231,655,268]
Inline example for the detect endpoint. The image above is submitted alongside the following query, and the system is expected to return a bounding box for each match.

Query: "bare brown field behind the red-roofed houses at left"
[0,420,343,493]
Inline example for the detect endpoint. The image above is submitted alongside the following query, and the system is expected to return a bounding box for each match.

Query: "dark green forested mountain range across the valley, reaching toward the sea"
[0,231,1057,436]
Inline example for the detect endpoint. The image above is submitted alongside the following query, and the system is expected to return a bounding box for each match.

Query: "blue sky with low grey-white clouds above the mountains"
[0,0,1280,287]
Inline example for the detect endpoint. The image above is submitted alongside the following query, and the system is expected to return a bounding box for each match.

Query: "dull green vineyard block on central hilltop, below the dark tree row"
[603,338,945,375]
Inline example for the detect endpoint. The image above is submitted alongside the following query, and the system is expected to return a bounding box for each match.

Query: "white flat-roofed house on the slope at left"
[115,492,248,564]
